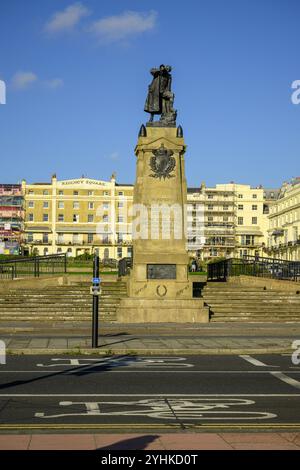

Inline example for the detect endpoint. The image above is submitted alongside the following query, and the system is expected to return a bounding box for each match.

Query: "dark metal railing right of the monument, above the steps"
[207,255,300,281]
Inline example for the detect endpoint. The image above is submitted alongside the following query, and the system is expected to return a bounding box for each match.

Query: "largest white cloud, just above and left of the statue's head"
[89,10,157,42]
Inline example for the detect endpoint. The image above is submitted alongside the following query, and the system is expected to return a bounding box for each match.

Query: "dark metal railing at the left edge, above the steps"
[0,253,67,279]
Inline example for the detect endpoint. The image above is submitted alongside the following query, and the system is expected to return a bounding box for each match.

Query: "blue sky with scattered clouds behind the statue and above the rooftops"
[0,0,300,187]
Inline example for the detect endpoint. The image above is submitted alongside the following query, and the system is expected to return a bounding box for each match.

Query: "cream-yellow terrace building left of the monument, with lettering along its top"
[22,175,133,259]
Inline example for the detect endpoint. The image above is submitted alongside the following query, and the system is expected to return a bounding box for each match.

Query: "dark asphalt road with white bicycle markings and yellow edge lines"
[0,355,300,432]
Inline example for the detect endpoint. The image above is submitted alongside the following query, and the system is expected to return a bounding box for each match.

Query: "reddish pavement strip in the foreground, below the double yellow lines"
[0,433,300,451]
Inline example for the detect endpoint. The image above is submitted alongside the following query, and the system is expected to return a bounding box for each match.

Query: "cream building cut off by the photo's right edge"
[268,177,300,261]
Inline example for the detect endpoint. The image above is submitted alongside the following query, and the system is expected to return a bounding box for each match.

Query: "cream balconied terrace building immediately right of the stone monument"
[188,183,276,260]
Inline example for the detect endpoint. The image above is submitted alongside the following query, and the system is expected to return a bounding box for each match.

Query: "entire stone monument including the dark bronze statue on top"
[117,66,208,323]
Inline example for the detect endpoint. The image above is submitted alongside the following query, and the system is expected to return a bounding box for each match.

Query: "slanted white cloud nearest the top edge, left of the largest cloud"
[45,2,90,33]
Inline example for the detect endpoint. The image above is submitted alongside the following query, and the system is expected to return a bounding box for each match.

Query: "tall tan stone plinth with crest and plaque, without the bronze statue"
[117,123,209,323]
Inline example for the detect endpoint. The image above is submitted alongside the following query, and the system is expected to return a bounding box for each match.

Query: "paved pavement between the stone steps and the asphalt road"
[0,323,300,355]
